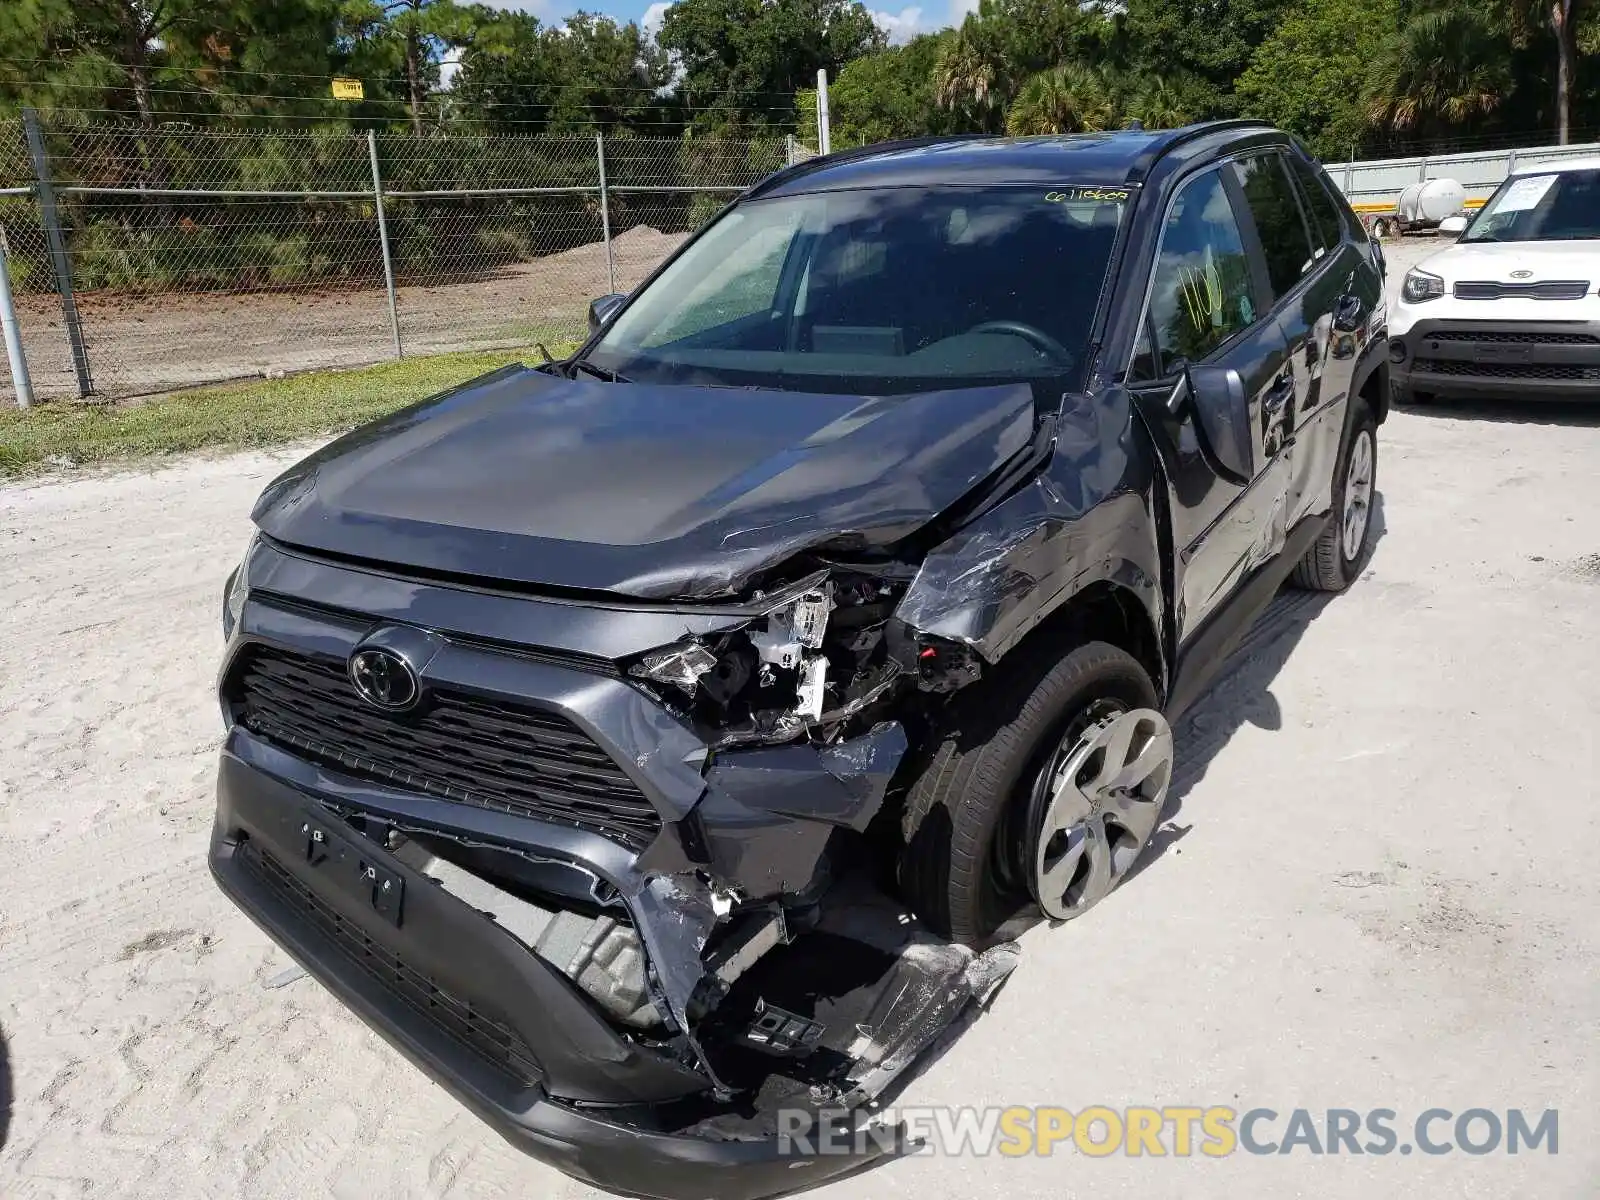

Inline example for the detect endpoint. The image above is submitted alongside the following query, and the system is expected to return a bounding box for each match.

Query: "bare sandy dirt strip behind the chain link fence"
[10,226,683,403]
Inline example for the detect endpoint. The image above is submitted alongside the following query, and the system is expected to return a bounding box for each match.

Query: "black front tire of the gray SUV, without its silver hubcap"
[899,642,1158,947]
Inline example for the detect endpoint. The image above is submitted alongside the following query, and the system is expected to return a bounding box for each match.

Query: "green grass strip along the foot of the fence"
[0,344,573,477]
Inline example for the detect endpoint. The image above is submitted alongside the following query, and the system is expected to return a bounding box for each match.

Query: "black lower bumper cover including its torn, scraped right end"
[210,752,1014,1200]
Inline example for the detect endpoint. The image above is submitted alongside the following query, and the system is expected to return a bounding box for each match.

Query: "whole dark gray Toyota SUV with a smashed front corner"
[211,122,1389,1198]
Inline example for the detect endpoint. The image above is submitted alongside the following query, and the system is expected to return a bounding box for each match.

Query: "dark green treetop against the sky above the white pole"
[656,0,886,130]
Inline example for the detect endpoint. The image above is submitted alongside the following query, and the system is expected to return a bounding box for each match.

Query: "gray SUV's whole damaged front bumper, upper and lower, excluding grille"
[210,539,985,1200]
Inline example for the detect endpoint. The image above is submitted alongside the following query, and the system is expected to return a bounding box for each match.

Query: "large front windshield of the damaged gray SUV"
[587,186,1128,394]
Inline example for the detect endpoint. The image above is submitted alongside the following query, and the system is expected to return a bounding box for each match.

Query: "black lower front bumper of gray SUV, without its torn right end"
[210,755,909,1200]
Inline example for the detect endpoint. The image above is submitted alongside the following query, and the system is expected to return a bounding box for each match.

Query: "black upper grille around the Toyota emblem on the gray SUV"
[229,646,661,850]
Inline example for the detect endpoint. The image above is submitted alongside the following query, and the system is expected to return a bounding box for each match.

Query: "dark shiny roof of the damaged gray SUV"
[750,122,1269,195]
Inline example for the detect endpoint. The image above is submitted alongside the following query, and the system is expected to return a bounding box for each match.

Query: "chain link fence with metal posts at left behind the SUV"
[0,114,808,403]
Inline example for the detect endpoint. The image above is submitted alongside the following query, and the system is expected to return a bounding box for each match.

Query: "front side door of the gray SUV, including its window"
[1130,165,1293,648]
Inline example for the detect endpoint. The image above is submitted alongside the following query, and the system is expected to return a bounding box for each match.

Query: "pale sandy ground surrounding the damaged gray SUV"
[0,251,1600,1200]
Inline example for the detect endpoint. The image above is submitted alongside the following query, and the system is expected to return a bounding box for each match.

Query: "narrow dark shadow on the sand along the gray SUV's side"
[1120,491,1389,886]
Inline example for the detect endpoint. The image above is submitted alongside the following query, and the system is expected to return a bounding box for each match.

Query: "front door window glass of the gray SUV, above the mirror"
[1134,171,1256,374]
